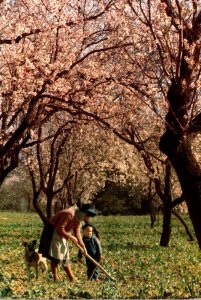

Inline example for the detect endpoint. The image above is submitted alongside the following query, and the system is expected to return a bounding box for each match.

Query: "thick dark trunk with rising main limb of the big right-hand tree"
[160,10,201,249]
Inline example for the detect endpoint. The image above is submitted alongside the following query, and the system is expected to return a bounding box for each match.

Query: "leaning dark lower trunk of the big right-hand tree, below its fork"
[160,129,201,249]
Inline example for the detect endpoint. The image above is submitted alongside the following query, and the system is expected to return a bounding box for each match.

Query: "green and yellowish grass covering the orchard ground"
[0,212,201,299]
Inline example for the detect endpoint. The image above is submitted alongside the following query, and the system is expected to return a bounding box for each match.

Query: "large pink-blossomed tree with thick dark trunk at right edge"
[80,0,201,248]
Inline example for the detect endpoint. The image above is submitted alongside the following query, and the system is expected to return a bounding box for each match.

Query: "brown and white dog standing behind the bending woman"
[23,240,48,278]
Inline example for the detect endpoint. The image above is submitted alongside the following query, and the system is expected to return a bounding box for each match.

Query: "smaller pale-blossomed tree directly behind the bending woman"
[22,112,143,222]
